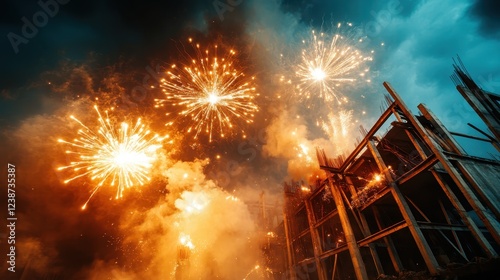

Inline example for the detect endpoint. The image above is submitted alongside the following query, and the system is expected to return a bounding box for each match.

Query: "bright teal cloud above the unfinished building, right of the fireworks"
[370,0,500,160]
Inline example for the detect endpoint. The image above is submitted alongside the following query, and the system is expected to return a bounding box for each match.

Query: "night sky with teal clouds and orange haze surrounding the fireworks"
[0,0,500,279]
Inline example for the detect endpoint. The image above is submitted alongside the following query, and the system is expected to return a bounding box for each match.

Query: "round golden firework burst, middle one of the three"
[156,39,258,142]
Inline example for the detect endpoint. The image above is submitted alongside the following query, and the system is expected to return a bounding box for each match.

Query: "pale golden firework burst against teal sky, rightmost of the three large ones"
[295,23,372,104]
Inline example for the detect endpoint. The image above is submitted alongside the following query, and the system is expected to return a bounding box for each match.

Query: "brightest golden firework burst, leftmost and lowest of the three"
[58,106,165,209]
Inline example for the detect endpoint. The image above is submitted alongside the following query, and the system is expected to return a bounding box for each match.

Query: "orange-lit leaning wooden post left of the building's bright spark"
[328,177,368,280]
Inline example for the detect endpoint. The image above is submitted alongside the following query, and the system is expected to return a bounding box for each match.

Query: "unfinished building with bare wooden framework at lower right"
[280,66,500,280]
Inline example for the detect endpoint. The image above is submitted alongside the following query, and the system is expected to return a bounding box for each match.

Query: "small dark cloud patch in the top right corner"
[470,0,500,38]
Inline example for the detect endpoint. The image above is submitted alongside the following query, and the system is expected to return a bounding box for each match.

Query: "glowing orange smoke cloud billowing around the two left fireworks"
[0,0,378,279]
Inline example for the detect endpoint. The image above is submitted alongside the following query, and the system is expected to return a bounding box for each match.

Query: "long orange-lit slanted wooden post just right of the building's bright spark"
[368,140,439,275]
